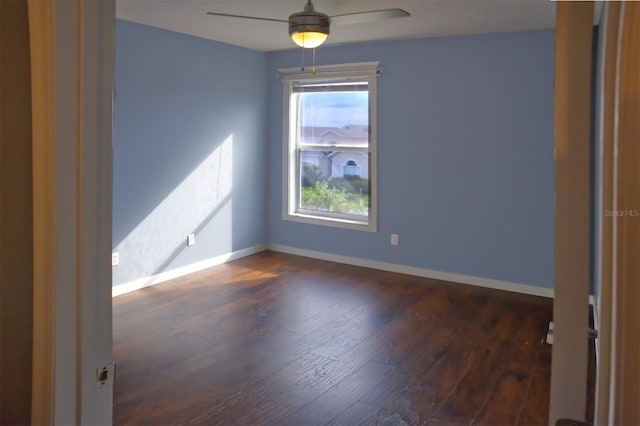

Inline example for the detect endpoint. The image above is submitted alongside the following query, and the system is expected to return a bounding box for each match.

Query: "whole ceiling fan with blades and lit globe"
[207,0,410,49]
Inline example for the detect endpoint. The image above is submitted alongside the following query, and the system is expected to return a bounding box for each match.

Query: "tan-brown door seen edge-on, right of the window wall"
[549,2,594,424]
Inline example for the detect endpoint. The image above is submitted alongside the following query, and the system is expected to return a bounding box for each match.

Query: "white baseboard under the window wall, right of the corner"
[267,244,553,298]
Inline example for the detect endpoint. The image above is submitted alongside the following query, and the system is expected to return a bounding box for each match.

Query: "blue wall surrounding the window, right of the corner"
[268,31,554,287]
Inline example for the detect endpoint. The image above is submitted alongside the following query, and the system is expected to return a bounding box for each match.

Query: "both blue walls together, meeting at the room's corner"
[113,21,554,287]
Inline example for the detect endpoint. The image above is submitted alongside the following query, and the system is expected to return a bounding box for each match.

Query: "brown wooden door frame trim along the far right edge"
[595,2,640,424]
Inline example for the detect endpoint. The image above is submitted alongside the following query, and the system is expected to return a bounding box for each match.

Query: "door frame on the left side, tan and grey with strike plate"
[28,0,115,424]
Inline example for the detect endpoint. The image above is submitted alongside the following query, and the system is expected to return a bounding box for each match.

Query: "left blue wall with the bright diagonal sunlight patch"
[113,21,268,285]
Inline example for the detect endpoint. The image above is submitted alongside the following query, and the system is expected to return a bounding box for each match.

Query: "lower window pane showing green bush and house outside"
[299,150,371,216]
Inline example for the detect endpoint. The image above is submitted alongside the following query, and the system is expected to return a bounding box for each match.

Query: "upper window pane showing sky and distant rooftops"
[297,86,369,148]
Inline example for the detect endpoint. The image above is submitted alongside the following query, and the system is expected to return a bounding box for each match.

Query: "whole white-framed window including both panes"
[281,63,378,231]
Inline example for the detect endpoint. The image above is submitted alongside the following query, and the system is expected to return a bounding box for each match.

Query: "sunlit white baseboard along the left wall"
[111,244,267,297]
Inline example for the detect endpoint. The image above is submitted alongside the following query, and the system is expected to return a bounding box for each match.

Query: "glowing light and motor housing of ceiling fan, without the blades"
[289,1,329,49]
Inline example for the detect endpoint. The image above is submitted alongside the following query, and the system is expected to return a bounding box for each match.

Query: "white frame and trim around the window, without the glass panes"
[279,62,379,232]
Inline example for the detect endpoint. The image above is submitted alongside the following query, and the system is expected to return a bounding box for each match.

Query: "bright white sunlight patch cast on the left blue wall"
[114,134,234,279]
